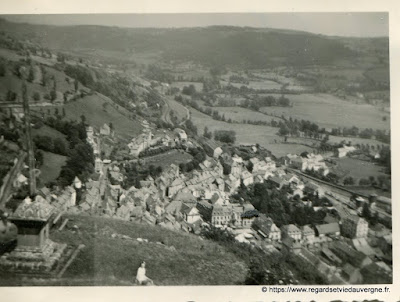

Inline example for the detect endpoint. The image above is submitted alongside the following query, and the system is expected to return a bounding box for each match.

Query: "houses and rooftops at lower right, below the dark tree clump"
[253,209,392,284]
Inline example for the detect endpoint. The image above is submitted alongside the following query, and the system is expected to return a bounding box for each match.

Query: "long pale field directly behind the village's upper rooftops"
[190,108,311,157]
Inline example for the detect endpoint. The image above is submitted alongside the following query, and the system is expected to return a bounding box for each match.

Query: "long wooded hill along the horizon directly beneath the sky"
[0,20,388,68]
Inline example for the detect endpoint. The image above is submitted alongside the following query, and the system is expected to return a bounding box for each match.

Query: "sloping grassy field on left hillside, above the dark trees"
[64,94,142,139]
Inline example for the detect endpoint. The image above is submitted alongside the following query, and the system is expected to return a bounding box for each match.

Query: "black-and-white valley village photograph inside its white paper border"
[0,0,394,301]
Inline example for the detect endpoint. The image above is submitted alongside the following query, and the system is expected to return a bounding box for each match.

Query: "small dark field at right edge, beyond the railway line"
[335,157,386,180]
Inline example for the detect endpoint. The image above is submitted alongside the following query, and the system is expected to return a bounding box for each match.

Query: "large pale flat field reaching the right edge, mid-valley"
[260,94,390,130]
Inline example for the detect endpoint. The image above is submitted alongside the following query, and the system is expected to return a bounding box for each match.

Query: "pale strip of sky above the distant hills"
[2,12,389,37]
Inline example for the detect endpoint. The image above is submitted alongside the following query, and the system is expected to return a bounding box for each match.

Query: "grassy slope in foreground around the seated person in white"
[47,215,247,285]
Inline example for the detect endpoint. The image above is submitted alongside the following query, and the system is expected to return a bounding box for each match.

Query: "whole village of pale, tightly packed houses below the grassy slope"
[0,110,392,284]
